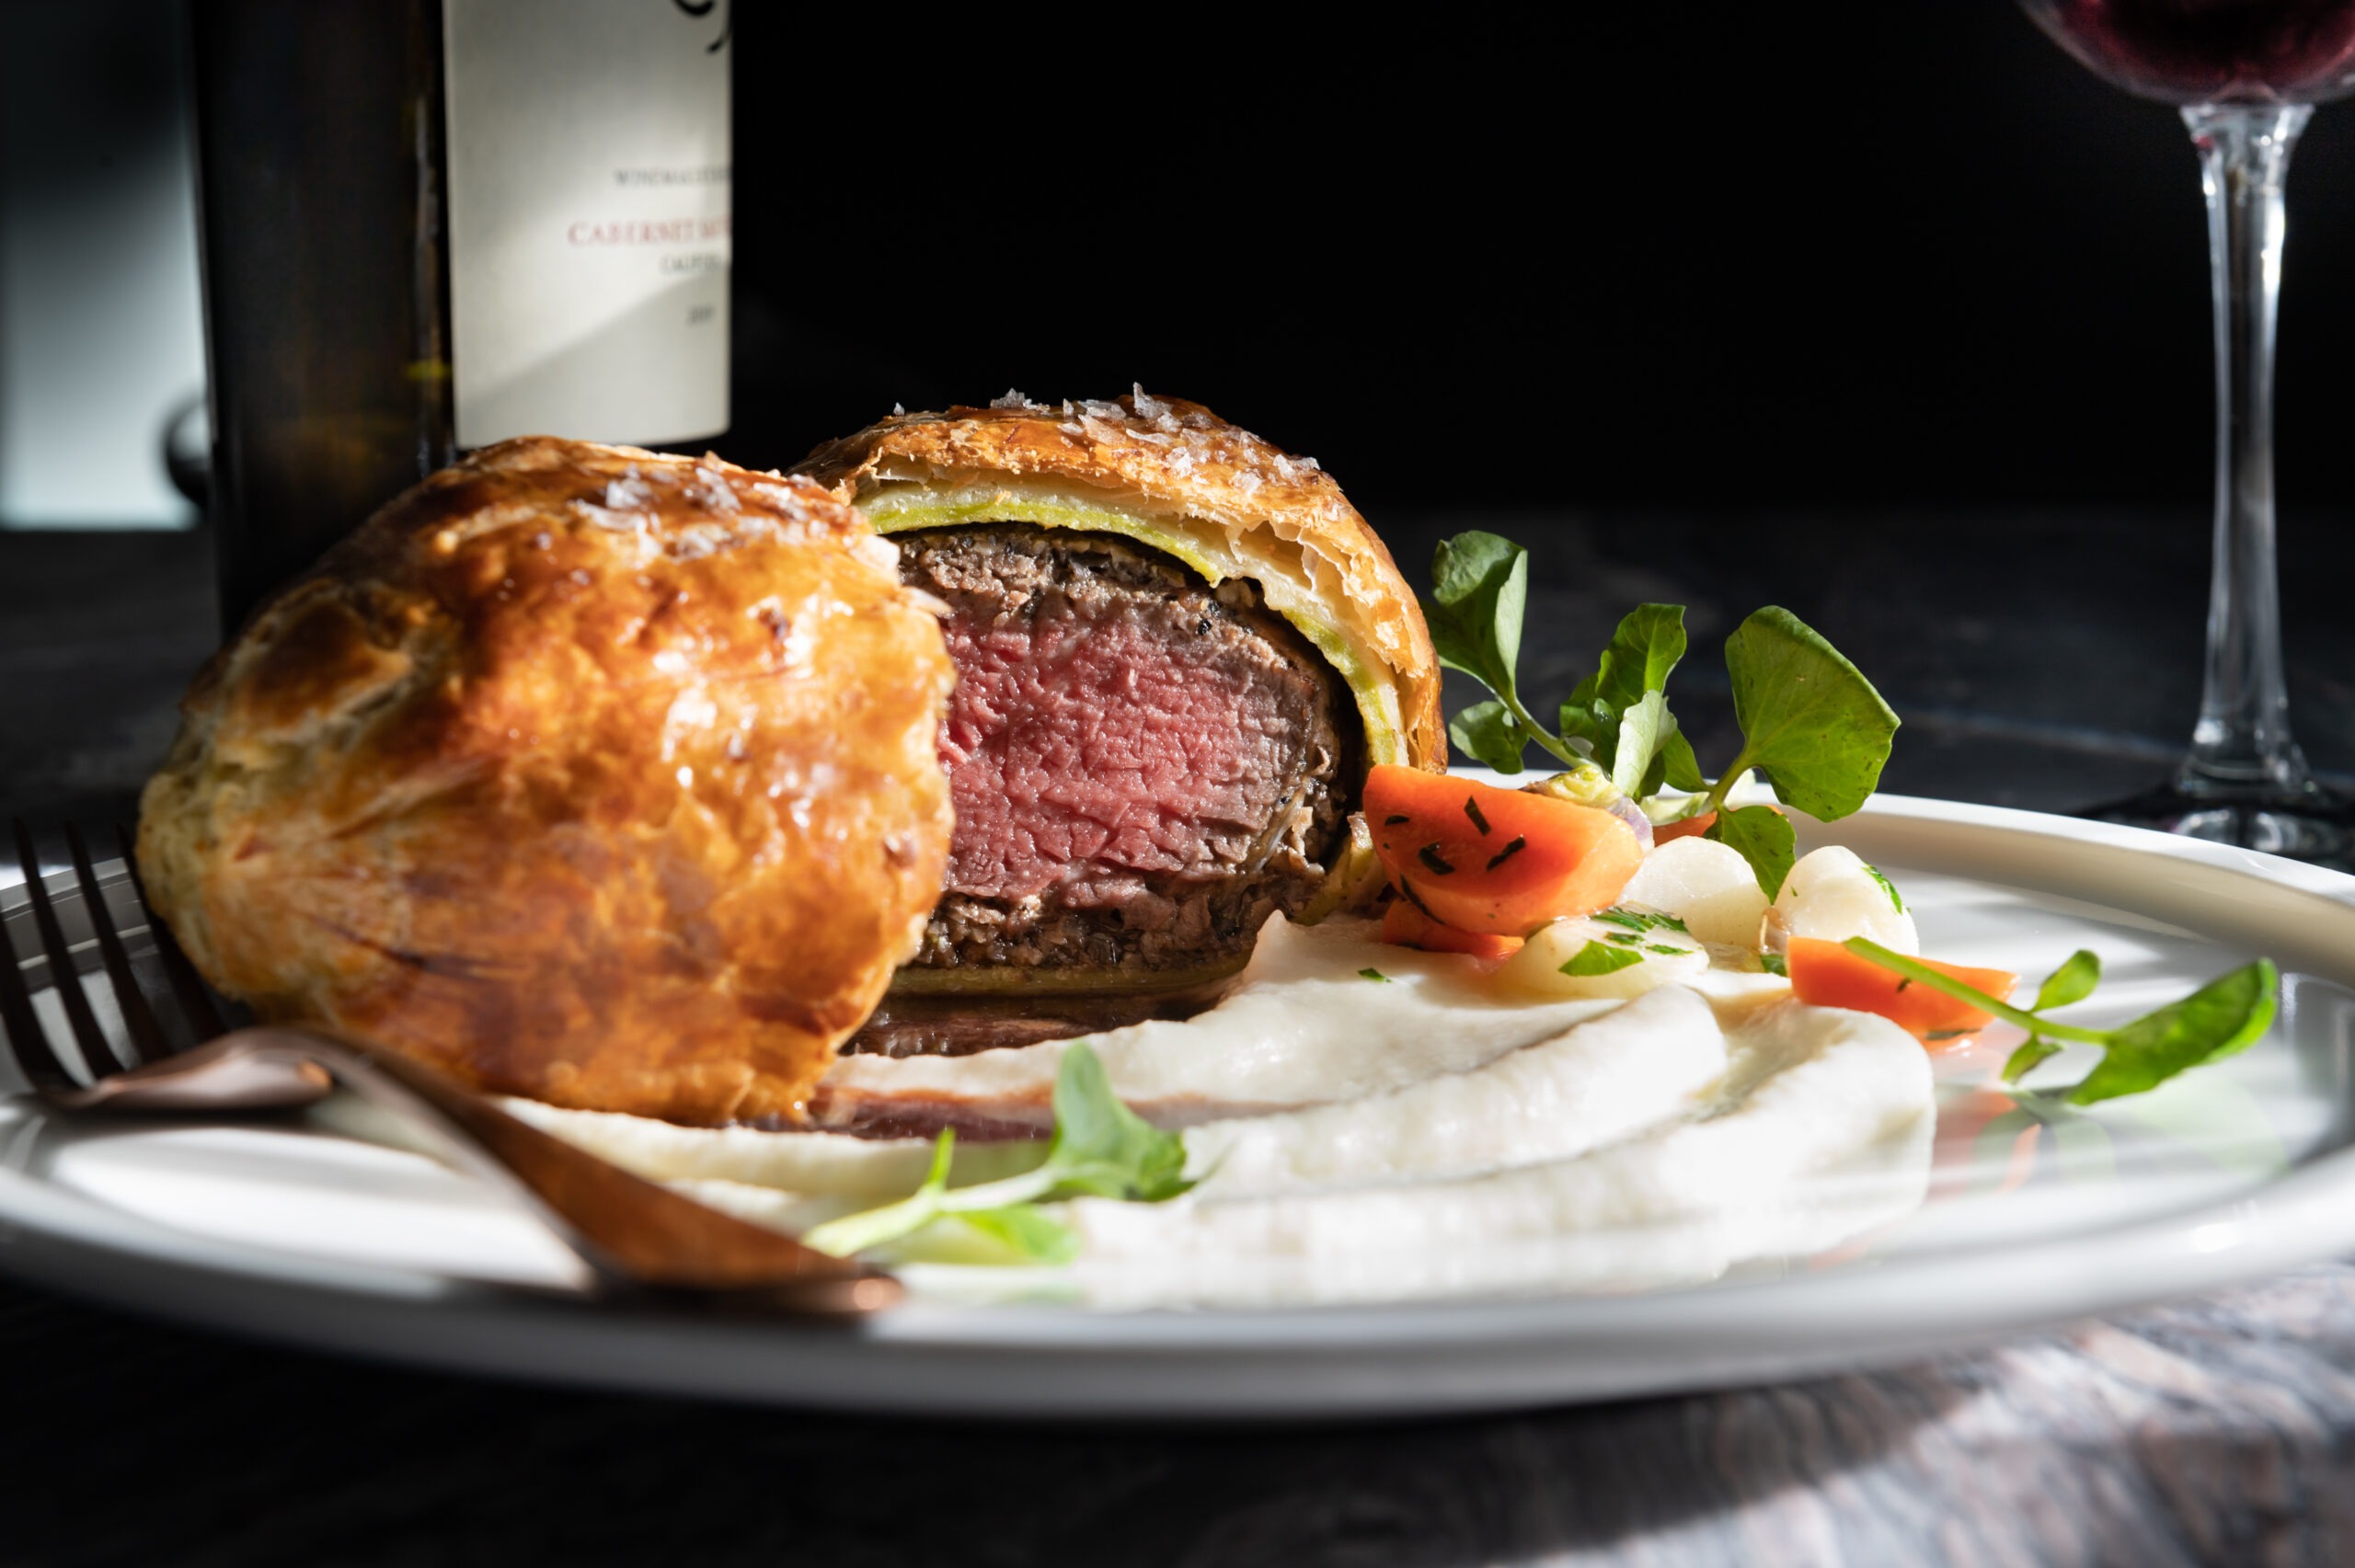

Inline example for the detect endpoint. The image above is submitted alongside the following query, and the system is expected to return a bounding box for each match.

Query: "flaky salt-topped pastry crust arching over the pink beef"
[794,388,1446,773]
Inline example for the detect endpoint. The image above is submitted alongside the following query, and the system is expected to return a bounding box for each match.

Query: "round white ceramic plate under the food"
[0,798,2355,1417]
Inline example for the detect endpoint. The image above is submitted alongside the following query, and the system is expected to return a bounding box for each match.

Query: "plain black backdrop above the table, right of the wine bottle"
[725,0,2355,515]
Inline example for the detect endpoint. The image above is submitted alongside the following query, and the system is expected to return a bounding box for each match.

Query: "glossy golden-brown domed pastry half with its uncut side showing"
[139,438,954,1123]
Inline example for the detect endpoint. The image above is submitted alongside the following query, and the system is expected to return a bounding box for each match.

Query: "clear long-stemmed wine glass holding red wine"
[2020,0,2355,864]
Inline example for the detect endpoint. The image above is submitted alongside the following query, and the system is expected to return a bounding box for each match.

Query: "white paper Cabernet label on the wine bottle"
[442,0,730,447]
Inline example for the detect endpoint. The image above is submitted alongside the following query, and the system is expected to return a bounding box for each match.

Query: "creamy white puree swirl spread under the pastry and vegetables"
[513,916,1934,1307]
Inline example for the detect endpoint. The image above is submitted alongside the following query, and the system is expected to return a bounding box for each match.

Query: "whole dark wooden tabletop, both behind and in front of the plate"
[0,513,2355,1568]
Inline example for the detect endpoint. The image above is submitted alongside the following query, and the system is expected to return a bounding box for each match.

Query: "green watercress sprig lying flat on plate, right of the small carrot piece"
[1844,937,2282,1104]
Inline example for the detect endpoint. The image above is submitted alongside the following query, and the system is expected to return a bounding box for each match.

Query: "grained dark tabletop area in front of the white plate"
[0,1265,2355,1568]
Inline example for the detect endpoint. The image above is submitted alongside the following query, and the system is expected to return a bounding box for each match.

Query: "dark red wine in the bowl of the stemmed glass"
[2030,0,2355,104]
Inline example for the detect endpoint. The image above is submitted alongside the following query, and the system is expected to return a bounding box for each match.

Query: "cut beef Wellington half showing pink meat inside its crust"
[796,388,1446,1007]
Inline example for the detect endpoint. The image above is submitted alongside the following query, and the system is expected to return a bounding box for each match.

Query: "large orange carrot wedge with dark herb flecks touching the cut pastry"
[1366,762,1644,937]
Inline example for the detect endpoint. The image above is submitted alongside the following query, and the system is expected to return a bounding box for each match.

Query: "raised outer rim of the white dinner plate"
[0,795,2355,1417]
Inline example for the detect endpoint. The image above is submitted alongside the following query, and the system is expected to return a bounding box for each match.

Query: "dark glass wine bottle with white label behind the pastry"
[193,0,732,629]
